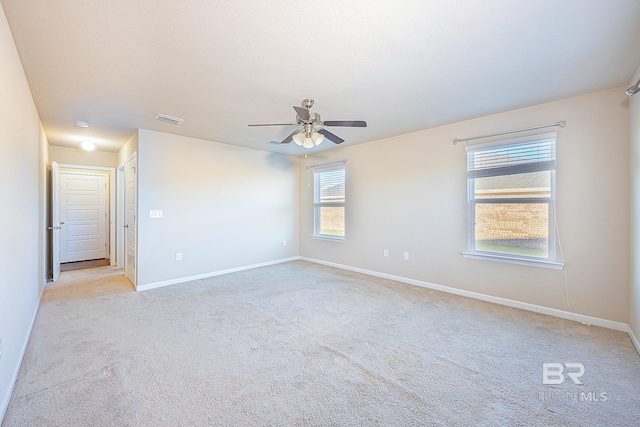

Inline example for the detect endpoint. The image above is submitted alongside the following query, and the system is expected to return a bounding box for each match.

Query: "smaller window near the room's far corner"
[313,166,345,239]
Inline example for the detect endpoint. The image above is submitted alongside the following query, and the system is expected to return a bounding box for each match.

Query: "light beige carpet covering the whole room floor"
[3,261,640,426]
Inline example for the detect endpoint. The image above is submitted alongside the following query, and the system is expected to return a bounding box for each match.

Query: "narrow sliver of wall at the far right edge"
[629,68,640,346]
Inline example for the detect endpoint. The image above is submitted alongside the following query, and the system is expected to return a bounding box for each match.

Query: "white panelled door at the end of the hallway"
[59,172,107,262]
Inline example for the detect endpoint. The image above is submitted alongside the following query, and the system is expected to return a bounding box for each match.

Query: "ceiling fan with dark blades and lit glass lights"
[249,99,367,148]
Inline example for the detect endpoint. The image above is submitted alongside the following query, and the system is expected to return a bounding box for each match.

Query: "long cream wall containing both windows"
[300,88,630,323]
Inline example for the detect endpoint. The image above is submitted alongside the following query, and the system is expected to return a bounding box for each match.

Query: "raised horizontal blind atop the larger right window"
[467,133,556,178]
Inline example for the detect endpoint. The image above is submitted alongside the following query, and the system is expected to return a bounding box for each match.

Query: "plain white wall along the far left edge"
[0,4,47,421]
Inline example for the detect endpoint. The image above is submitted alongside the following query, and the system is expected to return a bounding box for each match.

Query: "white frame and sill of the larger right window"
[462,132,563,269]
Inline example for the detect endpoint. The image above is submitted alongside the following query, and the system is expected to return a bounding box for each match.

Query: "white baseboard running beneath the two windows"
[300,257,639,334]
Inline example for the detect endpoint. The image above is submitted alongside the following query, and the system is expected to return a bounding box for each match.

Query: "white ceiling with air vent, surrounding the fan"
[0,0,640,155]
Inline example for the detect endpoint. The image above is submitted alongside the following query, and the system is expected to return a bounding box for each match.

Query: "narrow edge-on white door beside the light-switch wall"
[124,153,138,286]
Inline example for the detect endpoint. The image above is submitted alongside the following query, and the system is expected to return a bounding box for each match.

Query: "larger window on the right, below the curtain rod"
[465,133,556,263]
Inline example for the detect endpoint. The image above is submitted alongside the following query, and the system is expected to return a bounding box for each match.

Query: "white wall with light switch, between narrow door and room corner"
[137,129,299,287]
